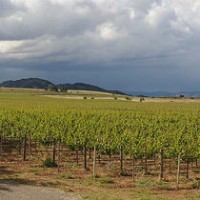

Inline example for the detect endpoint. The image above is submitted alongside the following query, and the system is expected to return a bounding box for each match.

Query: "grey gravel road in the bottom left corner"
[0,181,81,200]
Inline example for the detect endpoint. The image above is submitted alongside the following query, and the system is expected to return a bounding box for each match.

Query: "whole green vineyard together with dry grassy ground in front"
[0,90,200,200]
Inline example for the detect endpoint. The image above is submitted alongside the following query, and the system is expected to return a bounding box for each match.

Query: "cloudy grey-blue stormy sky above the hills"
[0,0,200,91]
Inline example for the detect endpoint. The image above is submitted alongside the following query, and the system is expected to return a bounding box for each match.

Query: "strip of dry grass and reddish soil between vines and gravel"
[0,161,200,200]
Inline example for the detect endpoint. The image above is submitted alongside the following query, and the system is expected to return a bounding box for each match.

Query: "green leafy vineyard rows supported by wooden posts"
[0,94,200,192]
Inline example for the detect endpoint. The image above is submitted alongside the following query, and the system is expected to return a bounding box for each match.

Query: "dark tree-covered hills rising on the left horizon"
[0,78,125,95]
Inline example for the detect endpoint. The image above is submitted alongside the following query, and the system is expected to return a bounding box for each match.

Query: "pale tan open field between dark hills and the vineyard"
[0,87,200,103]
